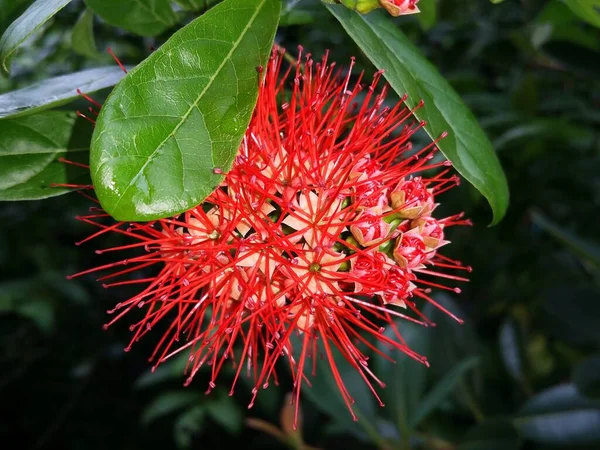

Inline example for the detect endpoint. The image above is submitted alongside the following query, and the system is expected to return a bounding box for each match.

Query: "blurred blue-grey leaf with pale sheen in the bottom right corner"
[513,384,600,445]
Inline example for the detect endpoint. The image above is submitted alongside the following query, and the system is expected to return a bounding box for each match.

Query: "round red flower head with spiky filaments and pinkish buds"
[69,49,470,426]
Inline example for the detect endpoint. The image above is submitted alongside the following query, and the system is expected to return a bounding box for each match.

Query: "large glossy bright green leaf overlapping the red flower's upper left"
[91,0,280,220]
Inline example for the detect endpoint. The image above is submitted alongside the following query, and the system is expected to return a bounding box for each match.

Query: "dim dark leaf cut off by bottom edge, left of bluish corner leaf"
[457,419,521,450]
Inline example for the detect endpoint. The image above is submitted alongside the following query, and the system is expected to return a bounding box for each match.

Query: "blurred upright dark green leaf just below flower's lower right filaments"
[375,320,431,431]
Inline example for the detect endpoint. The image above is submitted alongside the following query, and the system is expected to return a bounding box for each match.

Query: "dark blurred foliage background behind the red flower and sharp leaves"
[0,0,600,450]
